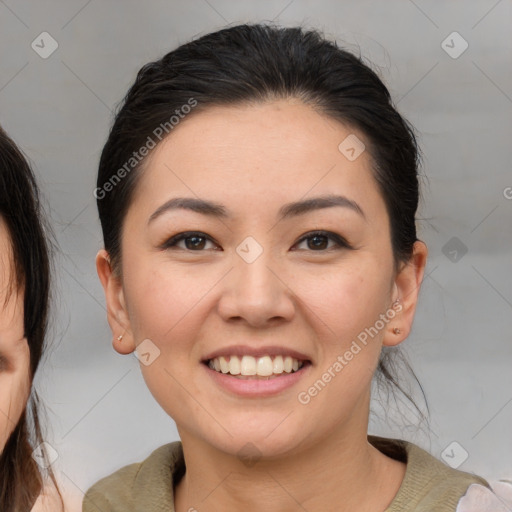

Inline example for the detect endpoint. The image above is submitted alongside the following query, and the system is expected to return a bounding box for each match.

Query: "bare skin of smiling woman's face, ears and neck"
[96,99,427,512]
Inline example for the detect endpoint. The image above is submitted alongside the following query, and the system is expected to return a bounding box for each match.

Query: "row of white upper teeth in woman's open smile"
[208,355,304,377]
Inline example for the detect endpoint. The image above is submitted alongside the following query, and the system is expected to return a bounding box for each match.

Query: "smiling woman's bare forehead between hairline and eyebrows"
[130,99,384,221]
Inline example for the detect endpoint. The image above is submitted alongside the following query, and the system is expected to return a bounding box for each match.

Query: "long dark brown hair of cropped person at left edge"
[0,127,57,512]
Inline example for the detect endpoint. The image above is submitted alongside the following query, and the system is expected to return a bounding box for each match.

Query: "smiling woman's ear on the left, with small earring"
[96,249,135,354]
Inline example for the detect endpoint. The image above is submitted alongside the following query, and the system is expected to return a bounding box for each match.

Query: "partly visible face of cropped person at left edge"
[0,217,30,453]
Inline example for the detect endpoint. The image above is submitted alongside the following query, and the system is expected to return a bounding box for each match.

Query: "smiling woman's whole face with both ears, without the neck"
[97,100,421,456]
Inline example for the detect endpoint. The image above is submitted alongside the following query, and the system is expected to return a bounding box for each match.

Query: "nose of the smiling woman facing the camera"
[218,252,295,327]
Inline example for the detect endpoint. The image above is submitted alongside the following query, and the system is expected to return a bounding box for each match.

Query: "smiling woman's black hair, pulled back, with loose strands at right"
[96,25,425,419]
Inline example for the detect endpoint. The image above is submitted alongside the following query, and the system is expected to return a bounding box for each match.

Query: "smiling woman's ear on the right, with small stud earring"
[382,241,428,347]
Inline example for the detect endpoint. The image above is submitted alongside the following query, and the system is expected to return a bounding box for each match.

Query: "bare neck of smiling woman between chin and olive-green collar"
[175,414,405,512]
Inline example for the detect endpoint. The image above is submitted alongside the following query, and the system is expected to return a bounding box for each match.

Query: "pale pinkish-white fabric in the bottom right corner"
[456,480,512,512]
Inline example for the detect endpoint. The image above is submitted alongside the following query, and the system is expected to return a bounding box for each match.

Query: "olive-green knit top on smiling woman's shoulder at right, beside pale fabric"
[369,436,489,512]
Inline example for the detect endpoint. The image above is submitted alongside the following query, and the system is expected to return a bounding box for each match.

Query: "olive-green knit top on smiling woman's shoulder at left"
[82,441,185,512]
